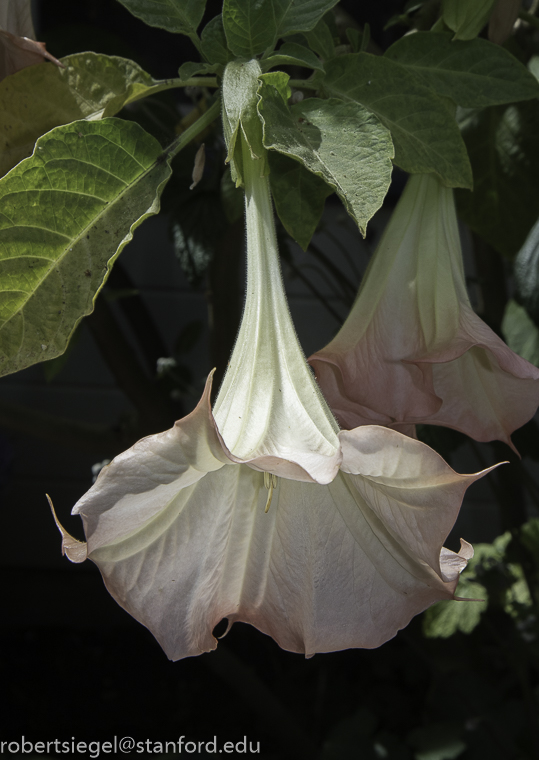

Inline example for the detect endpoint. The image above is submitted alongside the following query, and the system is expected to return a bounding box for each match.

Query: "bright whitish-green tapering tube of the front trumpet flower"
[214,137,341,483]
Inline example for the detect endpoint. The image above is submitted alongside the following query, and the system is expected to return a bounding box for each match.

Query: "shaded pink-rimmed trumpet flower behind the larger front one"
[309,175,539,446]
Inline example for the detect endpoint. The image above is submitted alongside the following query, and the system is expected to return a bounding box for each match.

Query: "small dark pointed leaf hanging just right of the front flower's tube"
[268,151,333,251]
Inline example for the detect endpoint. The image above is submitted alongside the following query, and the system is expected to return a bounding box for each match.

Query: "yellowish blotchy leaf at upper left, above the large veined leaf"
[0,53,168,176]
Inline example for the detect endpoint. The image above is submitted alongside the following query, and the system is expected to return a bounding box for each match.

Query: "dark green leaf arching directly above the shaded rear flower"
[322,53,472,187]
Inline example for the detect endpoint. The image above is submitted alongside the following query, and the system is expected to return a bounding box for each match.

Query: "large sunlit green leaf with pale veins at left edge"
[0,119,170,375]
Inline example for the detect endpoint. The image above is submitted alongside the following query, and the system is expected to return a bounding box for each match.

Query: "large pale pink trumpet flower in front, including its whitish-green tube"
[51,137,494,659]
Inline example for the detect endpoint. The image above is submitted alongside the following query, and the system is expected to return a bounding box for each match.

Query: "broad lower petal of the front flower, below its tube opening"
[79,465,476,659]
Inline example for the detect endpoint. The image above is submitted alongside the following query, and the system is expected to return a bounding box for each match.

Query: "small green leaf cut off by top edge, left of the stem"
[115,0,206,37]
